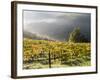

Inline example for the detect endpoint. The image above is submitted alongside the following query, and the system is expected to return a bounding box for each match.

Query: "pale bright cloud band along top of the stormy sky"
[24,11,90,25]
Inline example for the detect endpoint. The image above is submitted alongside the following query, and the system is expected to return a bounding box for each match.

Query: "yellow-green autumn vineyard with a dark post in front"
[23,38,91,69]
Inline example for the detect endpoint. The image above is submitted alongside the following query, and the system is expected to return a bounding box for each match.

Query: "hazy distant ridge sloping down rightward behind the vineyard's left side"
[23,31,56,41]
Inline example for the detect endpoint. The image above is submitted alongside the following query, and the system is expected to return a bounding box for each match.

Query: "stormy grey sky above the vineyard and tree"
[23,10,91,41]
